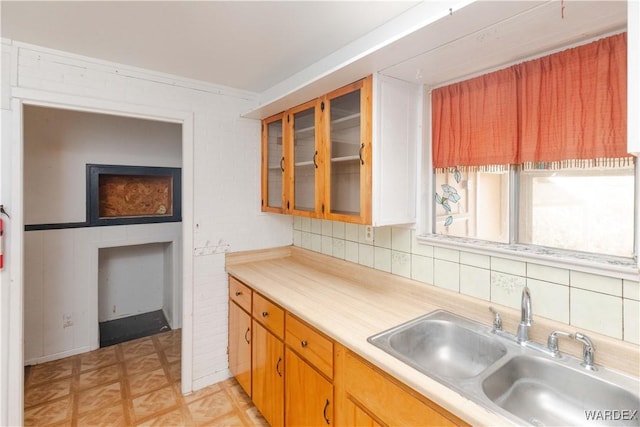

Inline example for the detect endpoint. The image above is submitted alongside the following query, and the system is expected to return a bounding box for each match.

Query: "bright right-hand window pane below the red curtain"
[518,164,635,258]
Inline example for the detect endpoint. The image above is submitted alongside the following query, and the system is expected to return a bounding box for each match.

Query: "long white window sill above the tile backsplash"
[417,234,640,282]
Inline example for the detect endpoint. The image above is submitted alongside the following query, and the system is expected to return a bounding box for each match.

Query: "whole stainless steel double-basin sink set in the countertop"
[368,310,640,426]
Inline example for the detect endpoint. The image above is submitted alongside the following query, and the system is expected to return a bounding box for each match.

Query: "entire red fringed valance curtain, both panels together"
[432,33,630,169]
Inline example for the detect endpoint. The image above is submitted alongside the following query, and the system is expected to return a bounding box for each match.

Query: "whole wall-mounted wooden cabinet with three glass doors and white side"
[262,76,422,226]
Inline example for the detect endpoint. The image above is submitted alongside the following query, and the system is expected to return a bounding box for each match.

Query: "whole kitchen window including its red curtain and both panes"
[432,33,638,257]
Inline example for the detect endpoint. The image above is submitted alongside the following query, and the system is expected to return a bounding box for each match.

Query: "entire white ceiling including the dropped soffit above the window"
[0,0,627,118]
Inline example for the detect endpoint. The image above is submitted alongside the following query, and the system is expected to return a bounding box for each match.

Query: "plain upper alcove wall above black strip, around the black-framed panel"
[23,106,182,224]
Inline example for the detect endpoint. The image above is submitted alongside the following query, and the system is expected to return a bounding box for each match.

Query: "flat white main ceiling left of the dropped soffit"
[1,1,418,93]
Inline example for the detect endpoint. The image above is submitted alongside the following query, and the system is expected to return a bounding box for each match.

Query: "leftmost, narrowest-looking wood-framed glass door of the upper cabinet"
[262,114,285,212]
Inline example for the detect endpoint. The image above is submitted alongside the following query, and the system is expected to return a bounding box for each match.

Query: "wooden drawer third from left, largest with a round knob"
[285,313,333,379]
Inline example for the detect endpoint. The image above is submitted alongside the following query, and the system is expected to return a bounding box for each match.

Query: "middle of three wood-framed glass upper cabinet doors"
[287,100,321,216]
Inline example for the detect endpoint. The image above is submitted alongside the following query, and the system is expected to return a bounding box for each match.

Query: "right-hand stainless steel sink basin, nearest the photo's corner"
[482,356,640,426]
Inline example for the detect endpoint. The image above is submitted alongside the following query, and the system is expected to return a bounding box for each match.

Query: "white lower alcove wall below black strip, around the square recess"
[24,222,183,364]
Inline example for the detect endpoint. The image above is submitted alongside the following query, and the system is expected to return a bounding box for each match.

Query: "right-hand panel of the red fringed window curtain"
[517,33,629,166]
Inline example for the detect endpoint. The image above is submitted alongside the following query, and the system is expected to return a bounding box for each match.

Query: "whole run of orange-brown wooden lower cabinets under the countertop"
[229,276,468,427]
